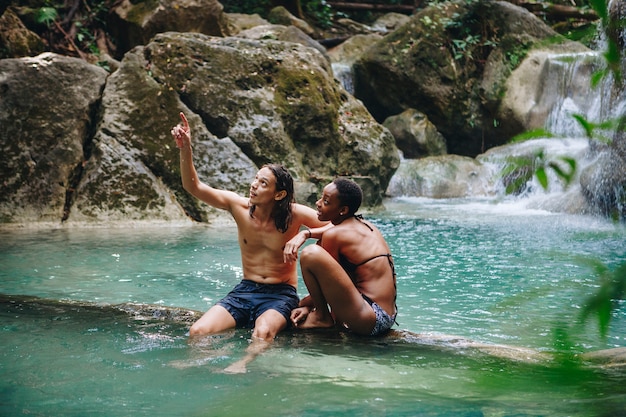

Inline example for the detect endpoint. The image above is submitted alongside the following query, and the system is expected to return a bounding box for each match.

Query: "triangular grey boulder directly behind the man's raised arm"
[70,47,256,222]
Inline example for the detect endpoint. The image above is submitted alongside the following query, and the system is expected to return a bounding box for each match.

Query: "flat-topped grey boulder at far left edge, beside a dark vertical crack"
[0,53,107,223]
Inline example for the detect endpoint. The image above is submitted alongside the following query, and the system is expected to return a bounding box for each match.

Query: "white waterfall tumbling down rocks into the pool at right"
[478,41,626,214]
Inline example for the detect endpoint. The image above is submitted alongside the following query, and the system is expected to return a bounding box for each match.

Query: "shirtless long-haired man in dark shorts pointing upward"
[171,113,326,371]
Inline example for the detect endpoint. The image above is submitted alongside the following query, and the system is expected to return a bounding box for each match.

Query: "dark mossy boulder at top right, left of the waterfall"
[354,0,584,156]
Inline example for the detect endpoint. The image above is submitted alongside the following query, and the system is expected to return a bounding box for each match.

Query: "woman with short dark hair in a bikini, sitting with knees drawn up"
[291,178,397,336]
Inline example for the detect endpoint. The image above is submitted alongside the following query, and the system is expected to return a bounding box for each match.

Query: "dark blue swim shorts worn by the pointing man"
[217,279,300,328]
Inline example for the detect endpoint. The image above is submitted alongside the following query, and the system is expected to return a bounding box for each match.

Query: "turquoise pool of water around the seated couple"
[0,200,626,417]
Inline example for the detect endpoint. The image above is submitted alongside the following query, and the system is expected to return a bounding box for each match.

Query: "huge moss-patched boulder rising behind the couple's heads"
[145,33,399,205]
